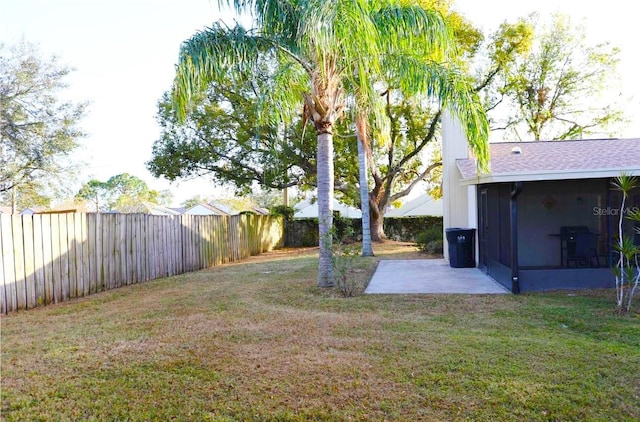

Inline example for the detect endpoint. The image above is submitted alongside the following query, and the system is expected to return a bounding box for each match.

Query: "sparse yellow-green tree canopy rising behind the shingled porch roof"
[486,14,623,140]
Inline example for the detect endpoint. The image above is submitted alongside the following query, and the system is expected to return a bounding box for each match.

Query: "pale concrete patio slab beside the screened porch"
[365,259,510,294]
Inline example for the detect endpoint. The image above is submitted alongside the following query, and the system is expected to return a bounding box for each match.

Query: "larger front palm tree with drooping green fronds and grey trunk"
[172,0,486,287]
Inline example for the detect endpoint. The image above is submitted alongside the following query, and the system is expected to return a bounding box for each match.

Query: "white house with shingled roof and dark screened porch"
[443,113,640,293]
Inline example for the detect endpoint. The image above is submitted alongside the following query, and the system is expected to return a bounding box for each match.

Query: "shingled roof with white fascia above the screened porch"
[456,138,640,185]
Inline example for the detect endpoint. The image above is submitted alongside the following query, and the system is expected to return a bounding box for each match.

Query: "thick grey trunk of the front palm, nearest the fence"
[316,132,333,287]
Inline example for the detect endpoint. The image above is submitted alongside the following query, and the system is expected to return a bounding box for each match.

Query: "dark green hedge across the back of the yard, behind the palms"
[285,216,442,247]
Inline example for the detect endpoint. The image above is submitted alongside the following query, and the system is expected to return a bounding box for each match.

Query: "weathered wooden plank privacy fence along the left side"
[0,213,284,313]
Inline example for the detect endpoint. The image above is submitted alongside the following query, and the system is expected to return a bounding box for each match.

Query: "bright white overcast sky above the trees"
[0,0,640,205]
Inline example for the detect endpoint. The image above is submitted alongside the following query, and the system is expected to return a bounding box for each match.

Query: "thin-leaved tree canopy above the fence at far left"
[0,41,86,209]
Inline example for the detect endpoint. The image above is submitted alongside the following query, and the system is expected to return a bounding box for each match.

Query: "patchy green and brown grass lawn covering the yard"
[1,243,640,421]
